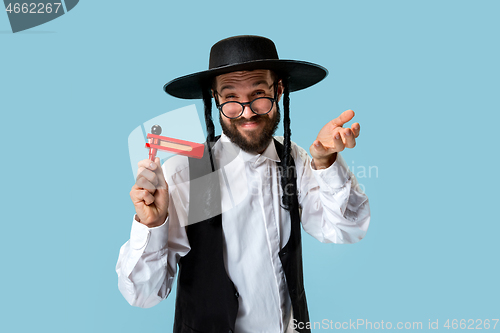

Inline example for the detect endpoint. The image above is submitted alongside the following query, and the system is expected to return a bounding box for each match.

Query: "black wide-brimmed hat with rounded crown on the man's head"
[163,36,328,99]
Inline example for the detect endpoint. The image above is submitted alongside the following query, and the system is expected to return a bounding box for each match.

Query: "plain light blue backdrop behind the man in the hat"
[0,1,500,332]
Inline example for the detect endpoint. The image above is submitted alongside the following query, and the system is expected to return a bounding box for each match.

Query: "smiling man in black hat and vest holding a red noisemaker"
[116,36,370,333]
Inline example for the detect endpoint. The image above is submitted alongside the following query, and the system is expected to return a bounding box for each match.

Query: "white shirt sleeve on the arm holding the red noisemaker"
[116,160,190,308]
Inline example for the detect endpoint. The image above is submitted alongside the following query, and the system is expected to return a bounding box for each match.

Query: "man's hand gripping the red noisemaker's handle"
[130,157,168,228]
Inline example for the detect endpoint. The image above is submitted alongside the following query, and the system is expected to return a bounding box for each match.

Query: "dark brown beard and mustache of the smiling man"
[219,105,281,153]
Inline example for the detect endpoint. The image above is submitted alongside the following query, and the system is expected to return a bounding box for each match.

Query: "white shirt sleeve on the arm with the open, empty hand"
[294,145,370,243]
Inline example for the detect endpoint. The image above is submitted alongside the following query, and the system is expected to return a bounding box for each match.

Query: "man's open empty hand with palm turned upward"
[309,110,360,169]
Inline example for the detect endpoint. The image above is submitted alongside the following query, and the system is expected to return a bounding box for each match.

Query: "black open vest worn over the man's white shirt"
[174,140,310,333]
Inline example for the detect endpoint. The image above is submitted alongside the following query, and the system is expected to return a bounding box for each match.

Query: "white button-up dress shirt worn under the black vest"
[116,134,370,333]
